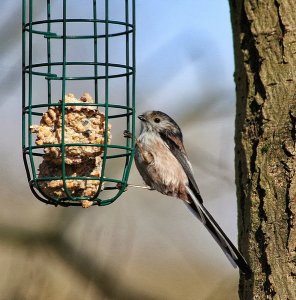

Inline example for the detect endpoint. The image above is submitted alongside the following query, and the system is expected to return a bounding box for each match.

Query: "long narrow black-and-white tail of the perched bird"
[186,187,252,275]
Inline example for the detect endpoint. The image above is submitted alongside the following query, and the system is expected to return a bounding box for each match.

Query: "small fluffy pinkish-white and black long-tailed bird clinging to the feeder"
[134,111,252,275]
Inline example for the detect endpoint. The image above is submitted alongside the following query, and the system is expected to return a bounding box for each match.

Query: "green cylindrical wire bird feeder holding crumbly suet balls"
[22,0,136,206]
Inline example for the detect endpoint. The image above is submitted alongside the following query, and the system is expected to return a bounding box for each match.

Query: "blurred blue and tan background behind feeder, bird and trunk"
[0,0,238,300]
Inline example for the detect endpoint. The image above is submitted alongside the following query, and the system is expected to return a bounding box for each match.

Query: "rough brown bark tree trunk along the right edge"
[229,0,296,300]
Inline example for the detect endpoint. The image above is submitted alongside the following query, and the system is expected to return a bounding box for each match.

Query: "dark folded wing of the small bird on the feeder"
[161,134,203,203]
